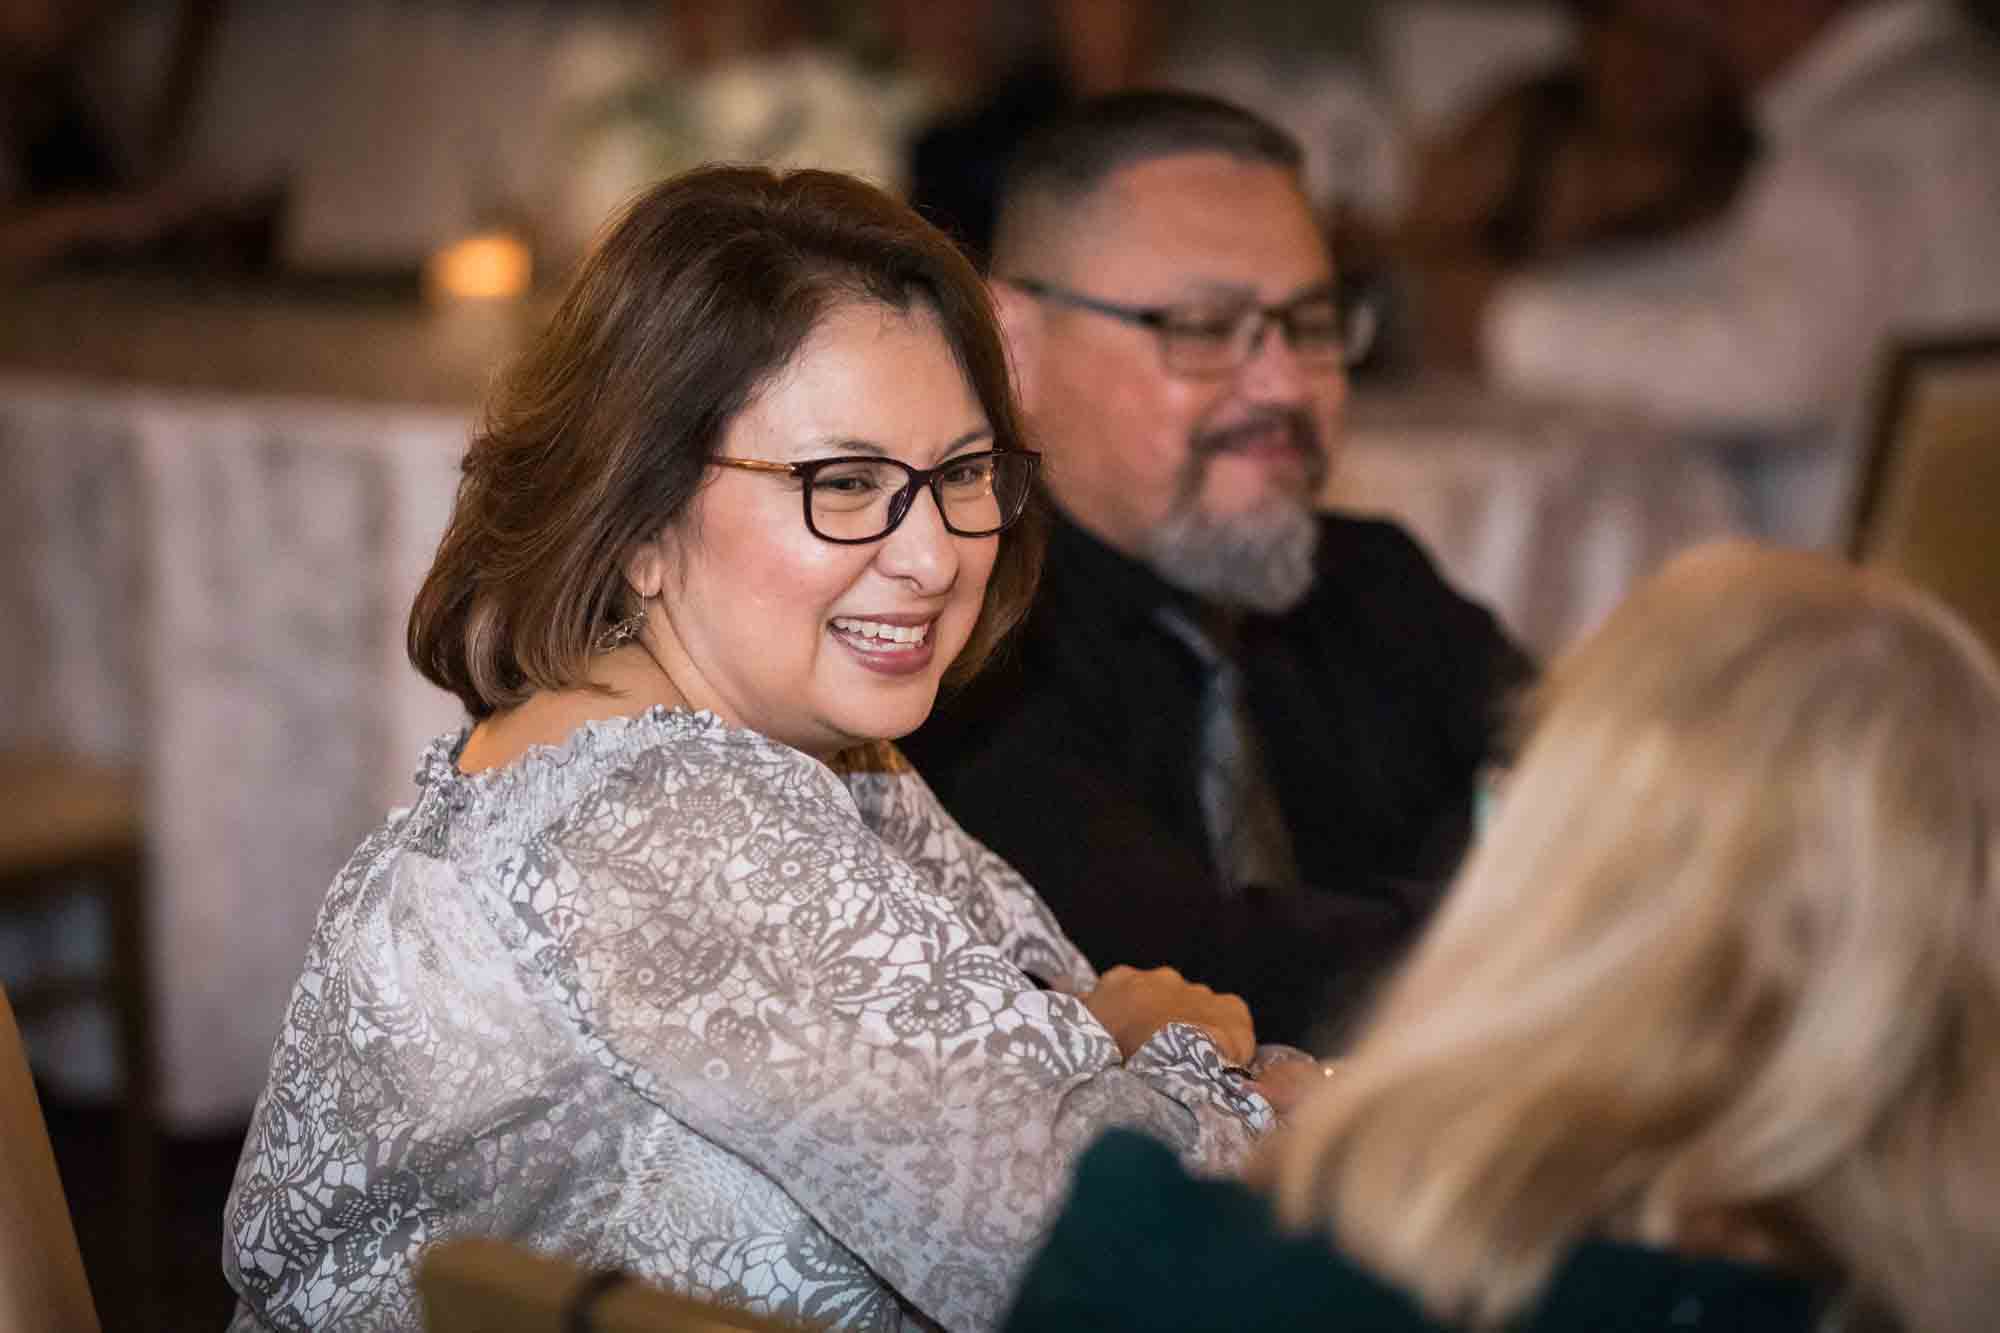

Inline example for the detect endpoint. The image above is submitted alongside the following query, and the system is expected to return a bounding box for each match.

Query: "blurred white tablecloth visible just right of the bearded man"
[1326,386,1750,656]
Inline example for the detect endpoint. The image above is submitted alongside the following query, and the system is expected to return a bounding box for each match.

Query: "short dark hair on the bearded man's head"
[994,88,1306,262]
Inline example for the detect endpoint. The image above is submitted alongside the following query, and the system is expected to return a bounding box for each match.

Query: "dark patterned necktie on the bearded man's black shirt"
[1160,608,1298,893]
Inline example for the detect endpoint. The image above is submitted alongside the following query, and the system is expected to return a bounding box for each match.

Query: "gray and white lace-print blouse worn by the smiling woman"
[224,709,1270,1329]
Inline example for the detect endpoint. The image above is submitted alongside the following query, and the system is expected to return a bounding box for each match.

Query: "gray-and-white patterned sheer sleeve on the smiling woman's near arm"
[514,740,1270,1329]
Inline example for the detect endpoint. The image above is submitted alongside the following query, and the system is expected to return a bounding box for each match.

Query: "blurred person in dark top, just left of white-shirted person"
[1396,0,1754,368]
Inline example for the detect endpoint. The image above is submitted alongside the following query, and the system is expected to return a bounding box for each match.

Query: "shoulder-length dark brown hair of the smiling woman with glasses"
[410,166,1042,717]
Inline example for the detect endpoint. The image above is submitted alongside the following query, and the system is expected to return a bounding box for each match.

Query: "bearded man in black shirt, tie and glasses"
[904,92,1528,1051]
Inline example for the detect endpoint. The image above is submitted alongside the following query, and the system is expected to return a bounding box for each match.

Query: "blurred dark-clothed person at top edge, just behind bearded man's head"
[884,0,1170,268]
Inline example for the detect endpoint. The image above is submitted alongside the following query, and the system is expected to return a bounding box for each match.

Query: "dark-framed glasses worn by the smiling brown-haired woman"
[710,448,1042,546]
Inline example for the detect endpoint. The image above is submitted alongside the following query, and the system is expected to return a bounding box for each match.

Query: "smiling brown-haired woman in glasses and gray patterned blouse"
[224,168,1272,1331]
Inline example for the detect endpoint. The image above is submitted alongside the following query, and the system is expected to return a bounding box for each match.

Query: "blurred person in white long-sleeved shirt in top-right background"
[1484,0,2000,544]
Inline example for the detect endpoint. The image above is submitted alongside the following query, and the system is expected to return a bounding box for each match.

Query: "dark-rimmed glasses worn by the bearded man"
[1008,278,1376,376]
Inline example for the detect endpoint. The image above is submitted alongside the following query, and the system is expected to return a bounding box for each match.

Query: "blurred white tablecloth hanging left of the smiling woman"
[0,378,468,1127]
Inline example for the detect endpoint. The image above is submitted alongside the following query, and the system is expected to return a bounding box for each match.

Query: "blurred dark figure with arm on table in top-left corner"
[0,0,282,274]
